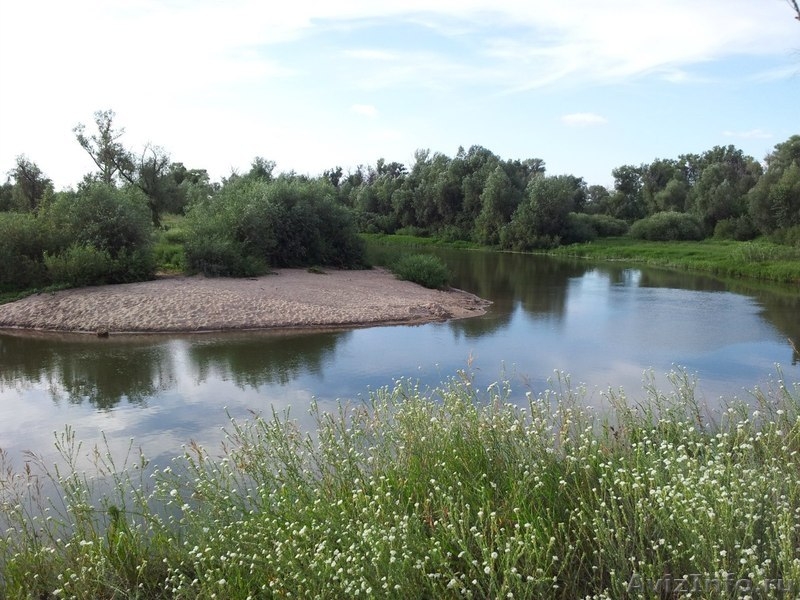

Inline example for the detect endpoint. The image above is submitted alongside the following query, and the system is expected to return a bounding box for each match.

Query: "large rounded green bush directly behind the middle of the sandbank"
[186,177,364,276]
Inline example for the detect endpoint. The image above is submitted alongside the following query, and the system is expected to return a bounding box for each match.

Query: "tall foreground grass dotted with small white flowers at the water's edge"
[0,373,800,598]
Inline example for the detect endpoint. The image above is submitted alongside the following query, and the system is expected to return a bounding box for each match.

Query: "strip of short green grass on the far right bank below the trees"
[550,238,800,283]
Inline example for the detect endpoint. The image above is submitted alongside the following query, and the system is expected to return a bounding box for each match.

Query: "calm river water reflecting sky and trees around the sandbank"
[0,250,800,464]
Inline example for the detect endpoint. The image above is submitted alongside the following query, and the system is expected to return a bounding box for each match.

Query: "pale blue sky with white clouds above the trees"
[0,0,800,189]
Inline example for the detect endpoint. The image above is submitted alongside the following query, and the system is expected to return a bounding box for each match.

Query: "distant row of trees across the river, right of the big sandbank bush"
[326,135,800,250]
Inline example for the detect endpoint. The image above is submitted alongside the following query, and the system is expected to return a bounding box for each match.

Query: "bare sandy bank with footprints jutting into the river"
[0,269,489,335]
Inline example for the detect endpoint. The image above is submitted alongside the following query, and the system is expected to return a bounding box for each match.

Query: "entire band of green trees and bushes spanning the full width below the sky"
[0,110,800,291]
